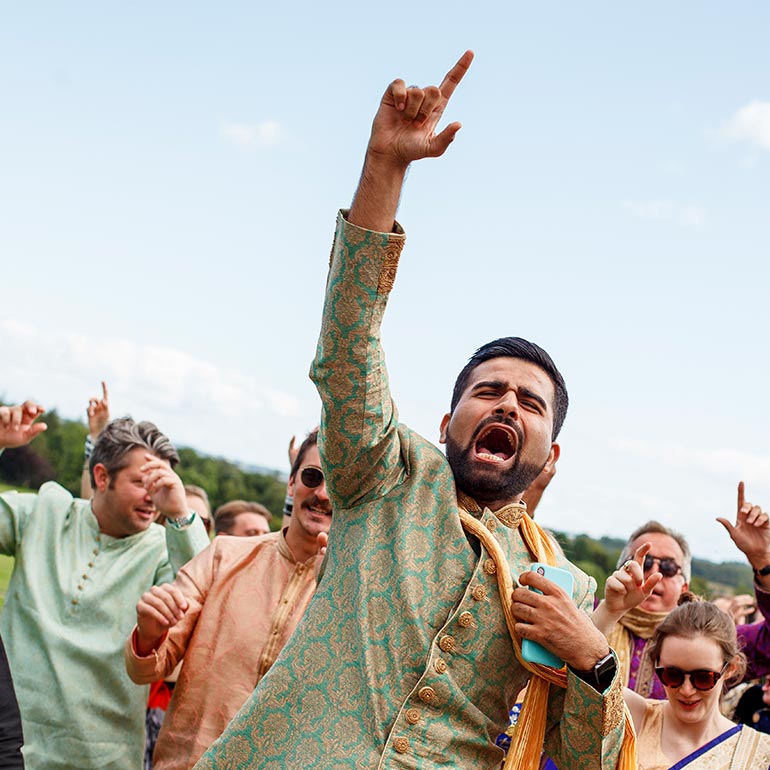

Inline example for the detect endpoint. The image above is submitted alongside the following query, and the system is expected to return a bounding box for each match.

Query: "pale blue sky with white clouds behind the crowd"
[0,2,770,558]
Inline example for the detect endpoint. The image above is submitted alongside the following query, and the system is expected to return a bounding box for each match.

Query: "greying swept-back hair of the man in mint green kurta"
[88,417,179,488]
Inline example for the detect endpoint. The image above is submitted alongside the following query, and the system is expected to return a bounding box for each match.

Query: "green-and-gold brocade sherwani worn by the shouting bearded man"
[195,216,623,770]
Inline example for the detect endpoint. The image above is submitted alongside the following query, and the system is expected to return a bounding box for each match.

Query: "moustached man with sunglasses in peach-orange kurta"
[126,432,331,770]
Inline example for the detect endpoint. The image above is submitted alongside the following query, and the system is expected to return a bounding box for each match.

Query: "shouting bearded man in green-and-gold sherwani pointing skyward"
[195,54,623,770]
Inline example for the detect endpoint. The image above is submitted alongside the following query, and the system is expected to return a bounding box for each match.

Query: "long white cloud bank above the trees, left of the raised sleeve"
[0,320,306,468]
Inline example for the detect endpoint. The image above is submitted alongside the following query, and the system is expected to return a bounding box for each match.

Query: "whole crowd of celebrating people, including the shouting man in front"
[0,52,770,770]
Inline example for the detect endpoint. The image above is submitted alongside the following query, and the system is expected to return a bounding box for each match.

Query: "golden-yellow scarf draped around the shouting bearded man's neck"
[459,495,636,770]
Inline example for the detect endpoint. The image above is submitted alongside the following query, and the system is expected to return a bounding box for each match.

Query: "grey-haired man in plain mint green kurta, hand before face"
[0,412,208,770]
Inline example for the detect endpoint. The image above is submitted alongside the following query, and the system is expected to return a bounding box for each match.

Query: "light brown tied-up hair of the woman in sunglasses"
[649,591,746,680]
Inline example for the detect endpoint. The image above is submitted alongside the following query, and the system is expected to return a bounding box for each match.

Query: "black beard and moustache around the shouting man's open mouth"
[446,420,545,503]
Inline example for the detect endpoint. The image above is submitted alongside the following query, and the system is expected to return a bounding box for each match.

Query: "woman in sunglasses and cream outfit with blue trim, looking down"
[624,592,770,770]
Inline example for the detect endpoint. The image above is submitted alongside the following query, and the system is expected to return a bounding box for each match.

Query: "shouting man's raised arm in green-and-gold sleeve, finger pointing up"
[311,52,473,510]
